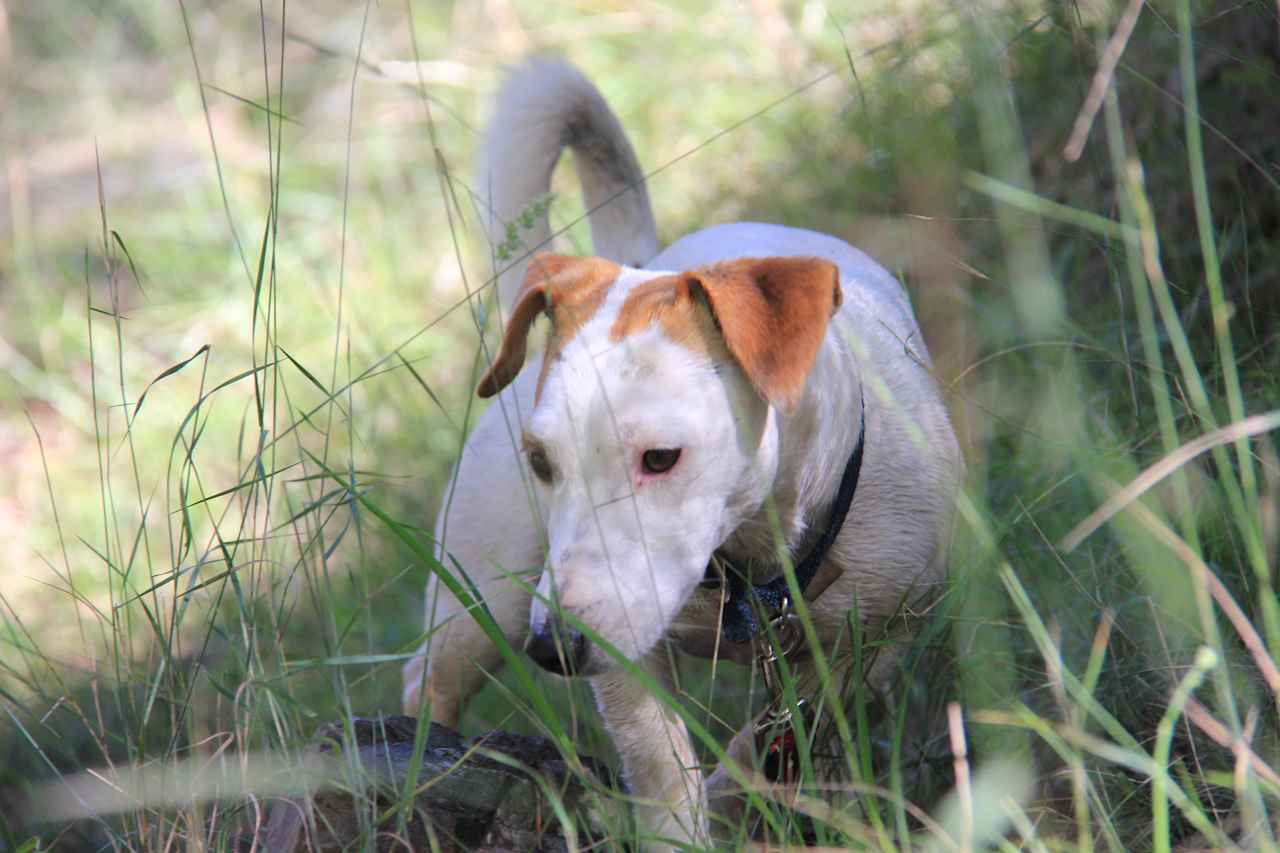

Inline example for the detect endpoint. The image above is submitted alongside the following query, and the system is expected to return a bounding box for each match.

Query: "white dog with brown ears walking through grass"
[404,60,961,849]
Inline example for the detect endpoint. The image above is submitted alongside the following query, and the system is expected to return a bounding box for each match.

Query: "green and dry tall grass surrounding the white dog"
[0,0,1280,850]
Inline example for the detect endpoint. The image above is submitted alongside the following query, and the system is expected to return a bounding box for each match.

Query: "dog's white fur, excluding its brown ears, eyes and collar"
[404,63,960,849]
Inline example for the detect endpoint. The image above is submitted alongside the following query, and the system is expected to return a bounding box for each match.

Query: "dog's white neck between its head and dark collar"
[722,334,863,571]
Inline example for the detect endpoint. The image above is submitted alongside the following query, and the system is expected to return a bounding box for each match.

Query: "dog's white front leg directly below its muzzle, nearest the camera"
[591,666,707,853]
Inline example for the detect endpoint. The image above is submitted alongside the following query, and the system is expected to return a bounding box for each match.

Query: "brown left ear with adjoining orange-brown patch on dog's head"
[476,252,622,397]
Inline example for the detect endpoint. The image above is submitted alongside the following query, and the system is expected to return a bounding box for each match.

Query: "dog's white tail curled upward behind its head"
[476,59,658,307]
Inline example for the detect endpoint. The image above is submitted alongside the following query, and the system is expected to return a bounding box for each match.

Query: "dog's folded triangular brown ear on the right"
[687,257,844,411]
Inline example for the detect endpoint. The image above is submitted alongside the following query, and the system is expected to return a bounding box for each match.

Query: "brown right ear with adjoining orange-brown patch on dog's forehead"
[609,257,842,410]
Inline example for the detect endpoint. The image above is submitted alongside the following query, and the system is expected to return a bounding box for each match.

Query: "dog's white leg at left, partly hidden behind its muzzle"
[402,383,543,726]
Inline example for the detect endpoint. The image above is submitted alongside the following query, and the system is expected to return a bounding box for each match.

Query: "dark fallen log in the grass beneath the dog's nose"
[256,716,631,853]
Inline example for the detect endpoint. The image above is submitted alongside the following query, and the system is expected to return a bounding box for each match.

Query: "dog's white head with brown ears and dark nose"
[477,254,841,675]
